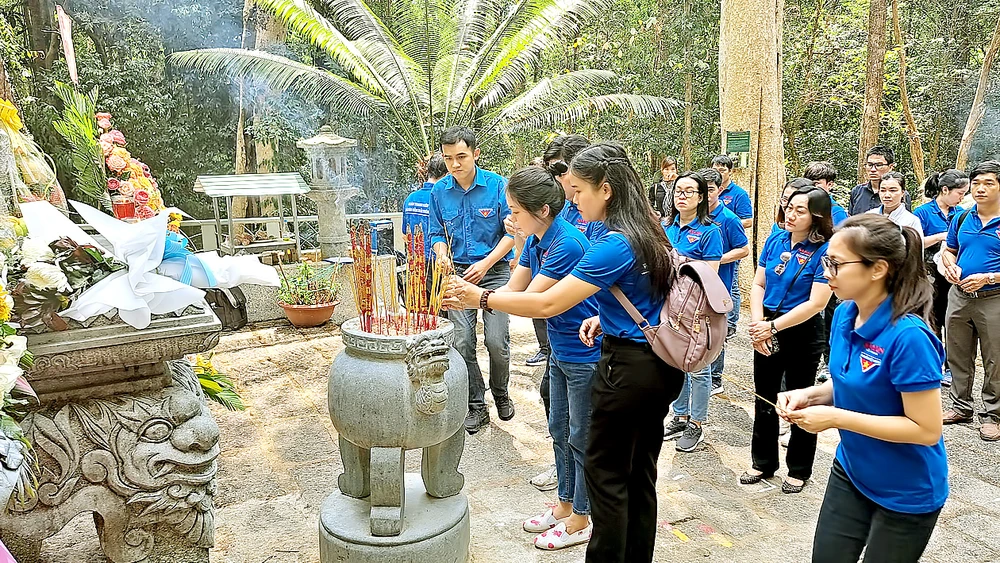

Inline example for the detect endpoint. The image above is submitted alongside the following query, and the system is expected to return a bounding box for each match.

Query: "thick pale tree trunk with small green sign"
[719,0,785,296]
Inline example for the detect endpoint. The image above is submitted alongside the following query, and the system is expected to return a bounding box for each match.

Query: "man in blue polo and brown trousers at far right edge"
[941,160,1000,442]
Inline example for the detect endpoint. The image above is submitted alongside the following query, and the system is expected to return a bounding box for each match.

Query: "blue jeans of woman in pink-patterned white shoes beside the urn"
[546,356,597,515]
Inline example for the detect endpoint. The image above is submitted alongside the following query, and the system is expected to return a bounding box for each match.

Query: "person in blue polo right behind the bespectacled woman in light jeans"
[698,168,750,395]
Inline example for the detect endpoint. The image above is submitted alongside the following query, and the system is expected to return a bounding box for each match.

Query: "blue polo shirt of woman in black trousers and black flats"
[757,231,827,313]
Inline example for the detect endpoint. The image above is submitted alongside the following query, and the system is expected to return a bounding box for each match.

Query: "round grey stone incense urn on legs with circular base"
[319,319,469,563]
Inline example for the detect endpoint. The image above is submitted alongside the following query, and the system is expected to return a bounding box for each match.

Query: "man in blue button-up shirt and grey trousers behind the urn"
[428,127,514,434]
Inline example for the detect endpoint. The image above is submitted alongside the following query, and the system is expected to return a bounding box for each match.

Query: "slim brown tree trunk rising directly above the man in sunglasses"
[858,0,887,184]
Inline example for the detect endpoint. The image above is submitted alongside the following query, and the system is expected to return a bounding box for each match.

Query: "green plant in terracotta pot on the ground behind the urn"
[278,263,340,328]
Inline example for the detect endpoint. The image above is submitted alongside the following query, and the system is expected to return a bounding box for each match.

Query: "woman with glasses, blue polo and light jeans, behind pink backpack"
[663,172,722,452]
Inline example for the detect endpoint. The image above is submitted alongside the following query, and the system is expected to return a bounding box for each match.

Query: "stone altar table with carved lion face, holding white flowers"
[0,309,222,563]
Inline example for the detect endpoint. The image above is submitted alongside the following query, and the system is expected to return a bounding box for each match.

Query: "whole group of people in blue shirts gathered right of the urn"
[400,128,1000,562]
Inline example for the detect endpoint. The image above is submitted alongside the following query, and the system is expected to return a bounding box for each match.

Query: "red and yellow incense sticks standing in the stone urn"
[351,222,448,336]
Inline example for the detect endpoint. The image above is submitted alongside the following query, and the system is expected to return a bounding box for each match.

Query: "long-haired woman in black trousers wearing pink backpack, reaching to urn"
[446,143,684,563]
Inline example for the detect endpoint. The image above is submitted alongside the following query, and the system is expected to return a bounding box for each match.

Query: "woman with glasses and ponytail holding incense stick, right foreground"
[777,215,948,563]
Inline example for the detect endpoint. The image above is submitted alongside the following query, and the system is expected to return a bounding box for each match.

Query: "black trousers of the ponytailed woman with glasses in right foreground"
[812,460,941,563]
